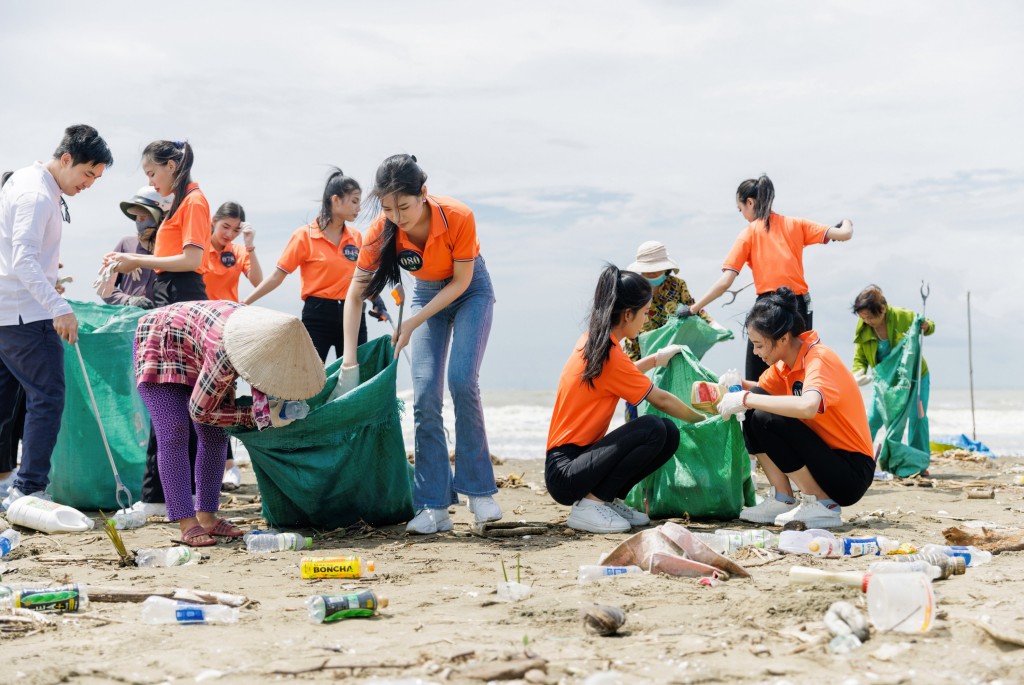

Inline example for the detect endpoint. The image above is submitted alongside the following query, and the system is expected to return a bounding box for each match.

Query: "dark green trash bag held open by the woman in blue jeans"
[228,336,414,529]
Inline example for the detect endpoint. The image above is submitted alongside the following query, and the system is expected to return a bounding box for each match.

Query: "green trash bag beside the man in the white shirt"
[49,302,150,512]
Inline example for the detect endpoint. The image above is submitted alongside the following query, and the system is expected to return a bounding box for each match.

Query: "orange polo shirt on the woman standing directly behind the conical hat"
[278,219,362,300]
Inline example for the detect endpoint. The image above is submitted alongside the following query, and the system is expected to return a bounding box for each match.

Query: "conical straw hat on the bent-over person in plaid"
[224,306,327,399]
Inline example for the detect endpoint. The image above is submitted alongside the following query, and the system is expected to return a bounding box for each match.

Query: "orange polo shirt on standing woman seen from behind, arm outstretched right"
[722,212,828,295]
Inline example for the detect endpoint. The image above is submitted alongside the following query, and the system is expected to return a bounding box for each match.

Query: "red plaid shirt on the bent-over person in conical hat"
[135,300,270,428]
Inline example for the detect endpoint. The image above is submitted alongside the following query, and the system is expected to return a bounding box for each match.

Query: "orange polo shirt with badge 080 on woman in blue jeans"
[358,196,480,281]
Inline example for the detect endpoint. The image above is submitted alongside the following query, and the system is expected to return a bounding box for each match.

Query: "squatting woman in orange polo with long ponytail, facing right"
[544,265,703,532]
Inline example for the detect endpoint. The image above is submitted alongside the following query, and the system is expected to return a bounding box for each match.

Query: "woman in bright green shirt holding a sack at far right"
[851,285,935,453]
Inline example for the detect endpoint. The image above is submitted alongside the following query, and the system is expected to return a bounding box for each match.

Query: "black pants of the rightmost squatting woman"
[743,388,874,507]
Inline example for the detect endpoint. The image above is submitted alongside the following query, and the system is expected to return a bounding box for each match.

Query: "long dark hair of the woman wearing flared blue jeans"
[366,155,427,299]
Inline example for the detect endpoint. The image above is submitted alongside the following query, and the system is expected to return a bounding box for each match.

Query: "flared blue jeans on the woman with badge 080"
[410,257,498,510]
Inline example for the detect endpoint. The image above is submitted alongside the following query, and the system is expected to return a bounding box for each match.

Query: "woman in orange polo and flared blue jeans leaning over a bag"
[339,155,502,533]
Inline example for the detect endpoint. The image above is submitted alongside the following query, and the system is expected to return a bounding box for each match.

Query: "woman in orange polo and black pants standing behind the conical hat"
[244,168,367,360]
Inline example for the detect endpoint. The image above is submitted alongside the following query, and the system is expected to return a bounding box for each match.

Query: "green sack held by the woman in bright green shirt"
[871,314,932,478]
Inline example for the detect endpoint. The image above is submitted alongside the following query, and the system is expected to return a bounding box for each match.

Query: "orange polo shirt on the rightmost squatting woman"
[758,327,874,458]
